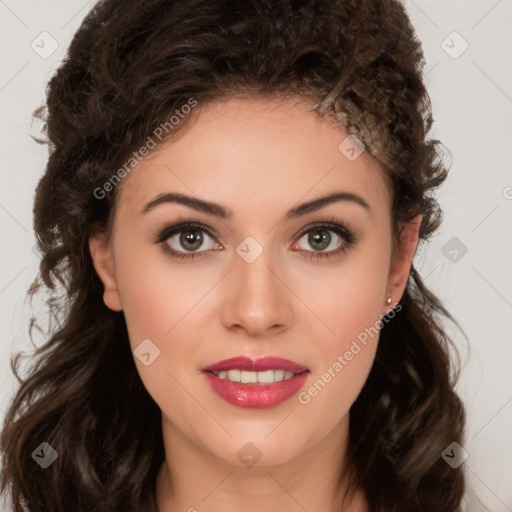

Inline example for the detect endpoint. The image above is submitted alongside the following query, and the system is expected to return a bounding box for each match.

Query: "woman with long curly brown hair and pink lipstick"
[1,0,465,512]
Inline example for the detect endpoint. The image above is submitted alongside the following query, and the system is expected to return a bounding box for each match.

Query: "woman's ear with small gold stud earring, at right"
[384,215,423,312]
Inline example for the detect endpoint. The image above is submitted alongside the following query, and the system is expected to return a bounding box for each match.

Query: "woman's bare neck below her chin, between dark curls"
[156,415,367,512]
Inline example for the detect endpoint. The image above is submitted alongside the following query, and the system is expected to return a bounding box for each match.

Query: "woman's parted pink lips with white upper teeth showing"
[202,357,310,409]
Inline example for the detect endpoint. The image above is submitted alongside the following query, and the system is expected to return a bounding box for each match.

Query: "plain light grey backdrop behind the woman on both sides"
[0,0,512,512]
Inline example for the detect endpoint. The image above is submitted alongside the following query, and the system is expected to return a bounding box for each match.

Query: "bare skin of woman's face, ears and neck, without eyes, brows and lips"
[90,98,421,512]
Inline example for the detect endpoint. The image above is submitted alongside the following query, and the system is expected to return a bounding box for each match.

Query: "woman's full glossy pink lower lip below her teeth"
[204,371,309,409]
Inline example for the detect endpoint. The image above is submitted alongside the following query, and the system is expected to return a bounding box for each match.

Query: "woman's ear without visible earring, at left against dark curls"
[89,235,123,311]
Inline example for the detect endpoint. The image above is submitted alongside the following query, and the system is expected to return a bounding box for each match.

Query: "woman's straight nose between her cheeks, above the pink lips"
[222,246,293,337]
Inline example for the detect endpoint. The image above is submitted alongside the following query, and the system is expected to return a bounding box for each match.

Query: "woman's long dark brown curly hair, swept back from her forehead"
[1,0,472,512]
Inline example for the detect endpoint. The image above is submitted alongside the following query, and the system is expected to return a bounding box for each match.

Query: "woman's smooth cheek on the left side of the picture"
[117,251,205,413]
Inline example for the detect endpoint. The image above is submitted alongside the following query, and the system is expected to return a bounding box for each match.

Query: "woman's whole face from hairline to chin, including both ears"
[90,99,419,465]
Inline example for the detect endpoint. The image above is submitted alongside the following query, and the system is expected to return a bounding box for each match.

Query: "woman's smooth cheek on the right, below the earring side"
[298,244,388,418]
